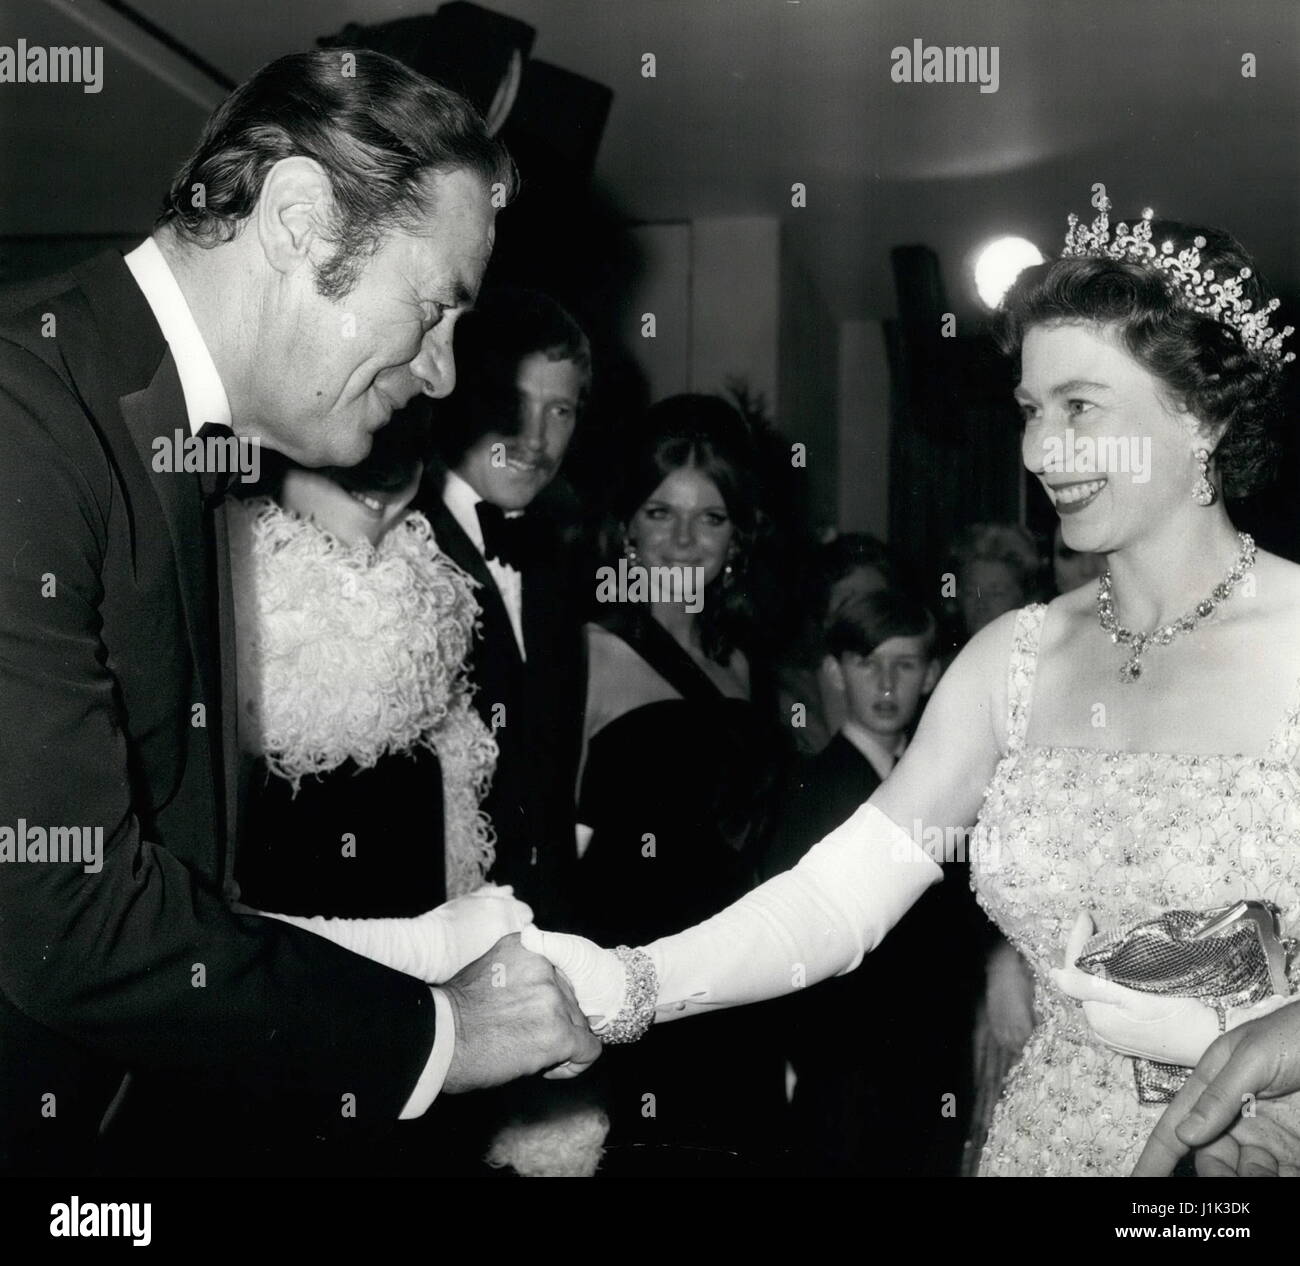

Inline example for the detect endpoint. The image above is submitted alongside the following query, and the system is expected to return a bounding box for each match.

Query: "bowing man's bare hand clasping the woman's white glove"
[441,932,601,1094]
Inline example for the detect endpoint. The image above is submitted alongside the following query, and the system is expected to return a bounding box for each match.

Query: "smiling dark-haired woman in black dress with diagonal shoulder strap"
[577,395,785,1172]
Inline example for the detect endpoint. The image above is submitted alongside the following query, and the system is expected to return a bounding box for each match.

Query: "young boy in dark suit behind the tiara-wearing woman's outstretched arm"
[768,590,979,1175]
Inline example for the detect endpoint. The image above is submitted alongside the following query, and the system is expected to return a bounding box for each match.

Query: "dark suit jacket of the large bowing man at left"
[0,255,434,1172]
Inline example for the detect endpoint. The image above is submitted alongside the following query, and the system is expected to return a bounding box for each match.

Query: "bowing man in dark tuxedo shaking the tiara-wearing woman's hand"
[0,51,599,1172]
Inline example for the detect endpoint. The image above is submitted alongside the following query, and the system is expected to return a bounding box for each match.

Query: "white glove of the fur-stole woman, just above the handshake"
[247,884,533,985]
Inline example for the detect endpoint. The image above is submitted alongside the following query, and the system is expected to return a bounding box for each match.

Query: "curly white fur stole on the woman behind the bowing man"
[230,499,497,899]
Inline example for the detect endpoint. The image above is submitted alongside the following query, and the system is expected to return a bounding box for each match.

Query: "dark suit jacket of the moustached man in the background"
[415,471,586,928]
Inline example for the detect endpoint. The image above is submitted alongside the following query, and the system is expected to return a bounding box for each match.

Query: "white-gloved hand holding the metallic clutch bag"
[1052,911,1292,1068]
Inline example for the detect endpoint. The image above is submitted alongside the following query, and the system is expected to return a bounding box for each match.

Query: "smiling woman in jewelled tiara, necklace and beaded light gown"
[524,196,1300,1175]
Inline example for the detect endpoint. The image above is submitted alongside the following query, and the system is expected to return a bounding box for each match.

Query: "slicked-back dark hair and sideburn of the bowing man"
[157,48,516,299]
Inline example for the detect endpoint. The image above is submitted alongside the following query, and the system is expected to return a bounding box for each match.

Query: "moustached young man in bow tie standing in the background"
[416,290,592,927]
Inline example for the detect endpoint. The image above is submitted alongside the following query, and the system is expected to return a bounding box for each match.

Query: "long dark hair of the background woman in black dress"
[601,395,771,663]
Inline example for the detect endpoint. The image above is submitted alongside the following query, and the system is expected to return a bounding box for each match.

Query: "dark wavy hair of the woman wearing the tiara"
[996,220,1281,497]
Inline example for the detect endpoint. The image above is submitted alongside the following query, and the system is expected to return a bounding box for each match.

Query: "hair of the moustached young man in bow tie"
[433,286,592,468]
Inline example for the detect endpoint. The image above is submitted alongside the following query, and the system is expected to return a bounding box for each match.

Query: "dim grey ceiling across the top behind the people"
[0,0,1300,317]
